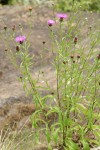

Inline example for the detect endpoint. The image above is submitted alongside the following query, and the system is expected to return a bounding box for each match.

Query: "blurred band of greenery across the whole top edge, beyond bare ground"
[0,0,100,11]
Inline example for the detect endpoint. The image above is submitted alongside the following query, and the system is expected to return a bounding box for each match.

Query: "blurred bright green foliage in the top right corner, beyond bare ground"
[56,0,100,11]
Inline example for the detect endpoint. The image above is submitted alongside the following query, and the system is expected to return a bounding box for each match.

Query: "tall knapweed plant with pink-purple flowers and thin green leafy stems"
[2,7,100,150]
